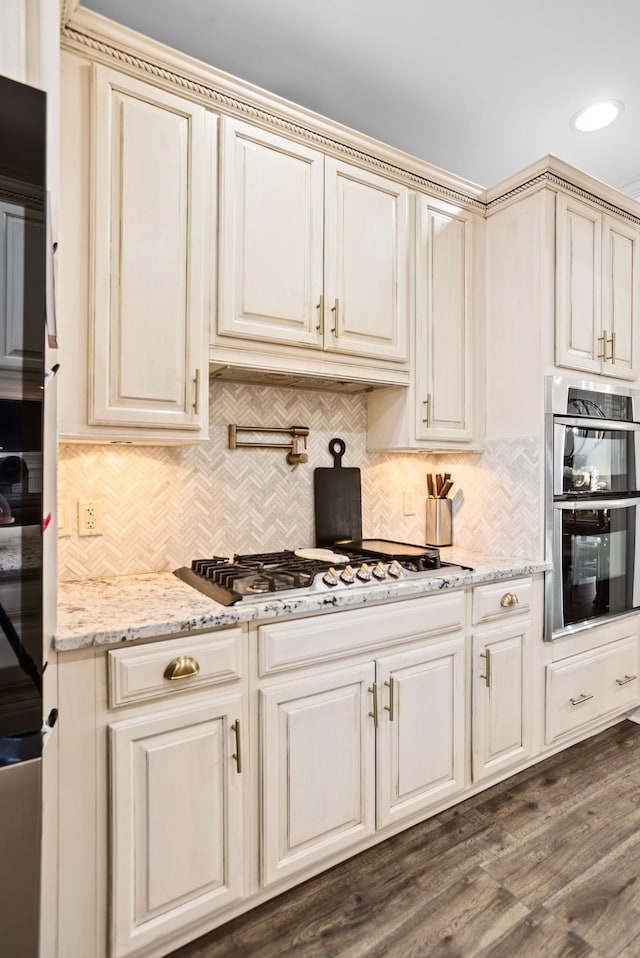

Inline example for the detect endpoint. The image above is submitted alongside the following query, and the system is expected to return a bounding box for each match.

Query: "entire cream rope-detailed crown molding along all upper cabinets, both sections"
[61,7,640,225]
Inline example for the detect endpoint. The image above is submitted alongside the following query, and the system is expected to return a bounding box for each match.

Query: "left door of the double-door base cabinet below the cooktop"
[260,663,375,884]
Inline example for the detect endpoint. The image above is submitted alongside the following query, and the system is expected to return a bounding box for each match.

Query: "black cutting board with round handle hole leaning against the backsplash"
[313,439,362,547]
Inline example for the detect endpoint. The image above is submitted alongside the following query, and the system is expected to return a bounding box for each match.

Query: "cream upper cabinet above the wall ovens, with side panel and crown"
[486,162,640,442]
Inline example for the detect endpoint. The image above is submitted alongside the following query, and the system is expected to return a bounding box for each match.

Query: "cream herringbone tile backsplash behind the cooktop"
[58,382,542,580]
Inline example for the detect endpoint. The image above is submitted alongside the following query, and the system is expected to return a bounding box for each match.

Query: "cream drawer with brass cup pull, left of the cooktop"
[108,628,242,708]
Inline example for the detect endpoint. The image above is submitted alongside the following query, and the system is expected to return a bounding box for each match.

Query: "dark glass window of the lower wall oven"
[562,506,636,626]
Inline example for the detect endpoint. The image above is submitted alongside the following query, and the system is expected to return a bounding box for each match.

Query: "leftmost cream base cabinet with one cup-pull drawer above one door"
[55,626,252,958]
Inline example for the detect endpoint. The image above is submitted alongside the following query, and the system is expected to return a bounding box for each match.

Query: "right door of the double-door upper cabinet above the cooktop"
[324,157,409,363]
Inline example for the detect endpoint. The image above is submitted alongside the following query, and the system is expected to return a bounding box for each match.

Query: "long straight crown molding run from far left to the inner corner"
[61,6,485,213]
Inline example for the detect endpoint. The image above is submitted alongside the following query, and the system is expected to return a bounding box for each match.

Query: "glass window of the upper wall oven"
[560,425,636,495]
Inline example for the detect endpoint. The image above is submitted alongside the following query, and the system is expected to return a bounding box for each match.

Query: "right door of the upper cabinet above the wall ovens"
[602,215,640,379]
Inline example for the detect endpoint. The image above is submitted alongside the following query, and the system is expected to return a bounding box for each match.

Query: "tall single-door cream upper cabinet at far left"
[60,55,212,443]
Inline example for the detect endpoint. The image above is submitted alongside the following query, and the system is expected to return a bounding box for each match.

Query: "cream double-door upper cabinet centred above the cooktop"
[211,118,409,382]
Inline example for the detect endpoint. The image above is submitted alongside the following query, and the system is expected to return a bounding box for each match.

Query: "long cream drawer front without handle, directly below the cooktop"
[258,592,464,675]
